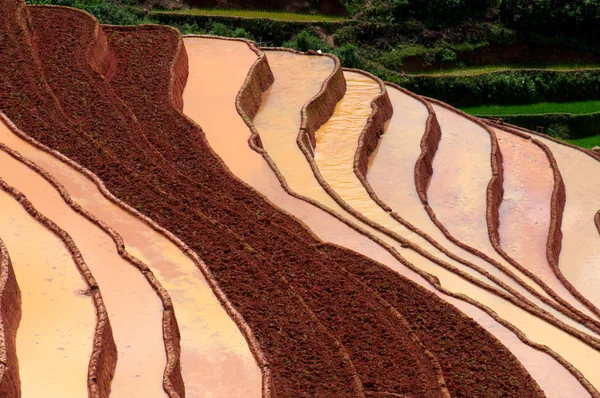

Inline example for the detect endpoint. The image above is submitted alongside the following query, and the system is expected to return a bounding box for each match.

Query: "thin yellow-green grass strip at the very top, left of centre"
[152,8,347,21]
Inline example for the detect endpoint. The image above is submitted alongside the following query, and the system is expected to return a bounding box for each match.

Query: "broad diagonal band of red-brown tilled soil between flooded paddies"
[0,1,541,397]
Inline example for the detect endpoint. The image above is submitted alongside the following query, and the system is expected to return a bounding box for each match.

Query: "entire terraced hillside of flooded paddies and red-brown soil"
[0,0,600,398]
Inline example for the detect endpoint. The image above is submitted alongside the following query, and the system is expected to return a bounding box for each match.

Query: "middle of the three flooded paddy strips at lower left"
[0,148,166,397]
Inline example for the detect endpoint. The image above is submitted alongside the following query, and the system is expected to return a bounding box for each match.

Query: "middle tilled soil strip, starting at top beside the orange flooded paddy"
[107,29,448,396]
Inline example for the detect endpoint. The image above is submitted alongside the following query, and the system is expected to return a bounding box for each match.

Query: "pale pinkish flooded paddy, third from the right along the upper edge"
[428,104,592,333]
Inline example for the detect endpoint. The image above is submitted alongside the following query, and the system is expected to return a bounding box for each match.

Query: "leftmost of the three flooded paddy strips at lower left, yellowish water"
[0,176,96,398]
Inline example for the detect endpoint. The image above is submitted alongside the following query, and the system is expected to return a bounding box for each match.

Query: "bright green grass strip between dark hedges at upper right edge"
[461,101,600,117]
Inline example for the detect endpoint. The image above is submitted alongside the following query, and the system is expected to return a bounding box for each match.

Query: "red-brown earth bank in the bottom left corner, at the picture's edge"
[0,239,21,398]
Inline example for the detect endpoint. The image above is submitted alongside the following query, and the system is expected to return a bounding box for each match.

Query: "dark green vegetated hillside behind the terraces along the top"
[27,0,600,139]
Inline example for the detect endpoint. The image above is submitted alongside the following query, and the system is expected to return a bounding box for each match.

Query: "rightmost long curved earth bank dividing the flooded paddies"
[482,119,600,330]
